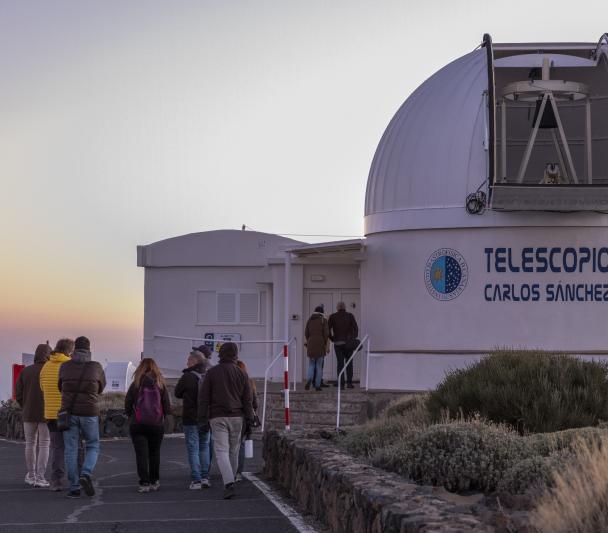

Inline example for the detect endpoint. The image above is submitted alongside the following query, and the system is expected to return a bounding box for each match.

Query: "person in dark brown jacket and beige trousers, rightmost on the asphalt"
[198,342,253,499]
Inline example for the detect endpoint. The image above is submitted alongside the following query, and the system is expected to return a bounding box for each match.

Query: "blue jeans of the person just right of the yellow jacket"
[63,415,99,490]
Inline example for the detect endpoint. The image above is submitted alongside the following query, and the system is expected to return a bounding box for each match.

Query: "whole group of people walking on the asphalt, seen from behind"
[16,337,257,499]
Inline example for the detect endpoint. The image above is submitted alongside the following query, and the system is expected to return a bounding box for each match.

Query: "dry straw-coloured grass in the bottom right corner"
[531,442,608,533]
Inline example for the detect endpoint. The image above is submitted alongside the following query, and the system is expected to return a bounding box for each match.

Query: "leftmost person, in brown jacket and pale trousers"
[15,343,51,488]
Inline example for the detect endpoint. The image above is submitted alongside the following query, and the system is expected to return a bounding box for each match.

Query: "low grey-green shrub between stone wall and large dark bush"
[372,420,531,492]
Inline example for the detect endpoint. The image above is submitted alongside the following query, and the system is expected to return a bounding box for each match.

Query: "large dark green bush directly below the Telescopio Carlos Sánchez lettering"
[427,351,608,433]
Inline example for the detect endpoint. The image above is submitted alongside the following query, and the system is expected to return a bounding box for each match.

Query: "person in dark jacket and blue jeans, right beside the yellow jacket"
[59,337,106,498]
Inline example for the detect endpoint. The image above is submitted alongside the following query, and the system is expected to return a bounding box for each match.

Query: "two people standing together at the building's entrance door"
[304,302,359,391]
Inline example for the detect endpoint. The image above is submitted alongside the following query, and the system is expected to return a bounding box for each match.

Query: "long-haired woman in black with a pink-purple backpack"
[125,357,171,492]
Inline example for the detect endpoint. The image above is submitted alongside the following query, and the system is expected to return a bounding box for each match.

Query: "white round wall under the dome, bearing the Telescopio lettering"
[362,227,608,390]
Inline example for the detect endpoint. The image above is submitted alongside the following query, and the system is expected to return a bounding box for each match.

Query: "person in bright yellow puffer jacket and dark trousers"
[40,339,74,492]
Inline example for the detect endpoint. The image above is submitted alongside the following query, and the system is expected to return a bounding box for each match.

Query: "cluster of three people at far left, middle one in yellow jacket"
[16,336,106,498]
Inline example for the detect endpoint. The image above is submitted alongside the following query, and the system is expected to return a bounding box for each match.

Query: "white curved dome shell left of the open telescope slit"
[365,49,488,233]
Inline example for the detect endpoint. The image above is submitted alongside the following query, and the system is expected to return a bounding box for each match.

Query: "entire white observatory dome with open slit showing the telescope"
[365,34,608,235]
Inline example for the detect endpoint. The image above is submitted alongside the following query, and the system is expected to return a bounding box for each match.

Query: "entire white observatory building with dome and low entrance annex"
[138,34,608,390]
